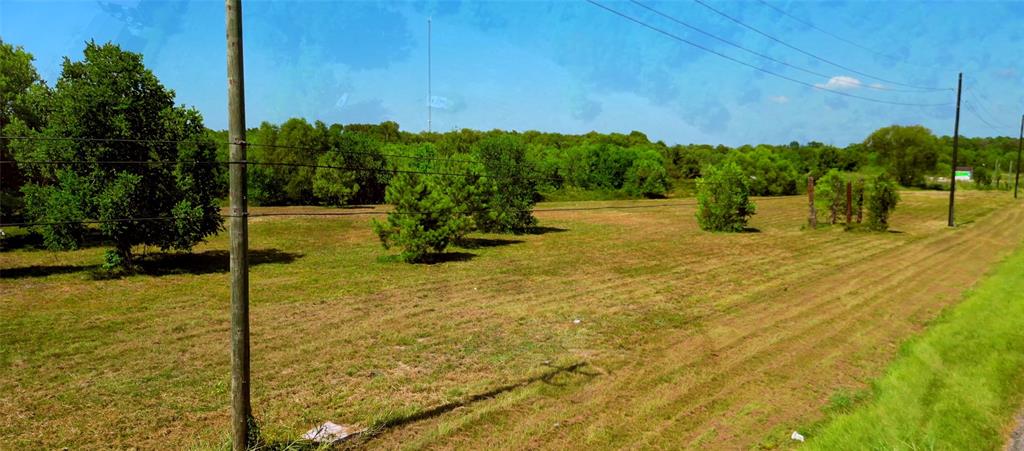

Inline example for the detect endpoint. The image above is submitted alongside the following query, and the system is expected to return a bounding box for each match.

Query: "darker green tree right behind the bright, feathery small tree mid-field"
[472,134,538,233]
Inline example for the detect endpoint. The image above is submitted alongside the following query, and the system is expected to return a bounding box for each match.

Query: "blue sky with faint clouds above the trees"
[0,0,1024,146]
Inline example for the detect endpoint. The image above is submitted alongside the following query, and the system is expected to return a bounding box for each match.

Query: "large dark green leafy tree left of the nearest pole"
[16,42,222,267]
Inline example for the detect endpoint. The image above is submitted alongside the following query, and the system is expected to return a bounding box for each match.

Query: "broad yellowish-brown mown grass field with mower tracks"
[0,192,1024,449]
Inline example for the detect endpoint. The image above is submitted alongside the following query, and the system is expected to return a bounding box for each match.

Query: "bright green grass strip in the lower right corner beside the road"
[808,242,1024,450]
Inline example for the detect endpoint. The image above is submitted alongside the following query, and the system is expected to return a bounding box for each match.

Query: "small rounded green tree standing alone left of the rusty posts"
[697,162,757,232]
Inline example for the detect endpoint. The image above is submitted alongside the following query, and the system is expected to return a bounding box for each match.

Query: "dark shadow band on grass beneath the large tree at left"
[0,249,302,280]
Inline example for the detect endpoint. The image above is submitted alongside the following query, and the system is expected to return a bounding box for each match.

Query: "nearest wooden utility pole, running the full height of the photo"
[224,0,252,451]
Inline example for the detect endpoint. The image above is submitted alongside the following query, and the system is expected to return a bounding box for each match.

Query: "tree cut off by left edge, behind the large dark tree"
[0,38,49,221]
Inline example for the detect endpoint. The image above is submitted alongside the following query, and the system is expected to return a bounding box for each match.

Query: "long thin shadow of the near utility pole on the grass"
[253,362,598,450]
